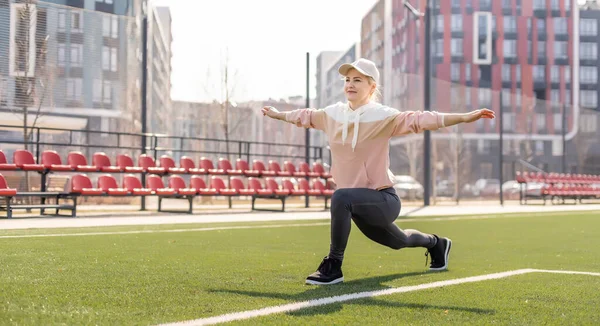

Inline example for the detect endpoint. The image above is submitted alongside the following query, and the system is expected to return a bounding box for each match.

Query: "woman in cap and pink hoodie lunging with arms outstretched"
[262,59,495,285]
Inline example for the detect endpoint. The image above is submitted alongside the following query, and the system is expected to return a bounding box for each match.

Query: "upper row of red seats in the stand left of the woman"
[0,150,331,179]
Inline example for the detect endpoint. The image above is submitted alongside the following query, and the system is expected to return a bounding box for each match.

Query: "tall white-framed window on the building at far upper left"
[8,3,37,77]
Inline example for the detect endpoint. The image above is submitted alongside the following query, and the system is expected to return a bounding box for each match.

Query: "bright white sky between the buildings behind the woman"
[153,0,377,102]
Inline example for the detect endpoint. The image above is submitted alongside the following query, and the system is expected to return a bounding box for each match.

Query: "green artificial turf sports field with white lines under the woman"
[0,212,600,325]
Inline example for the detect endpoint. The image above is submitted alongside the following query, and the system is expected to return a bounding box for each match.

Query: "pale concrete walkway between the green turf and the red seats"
[0,204,600,230]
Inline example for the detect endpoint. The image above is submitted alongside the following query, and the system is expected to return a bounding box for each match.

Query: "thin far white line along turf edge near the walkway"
[0,212,596,239]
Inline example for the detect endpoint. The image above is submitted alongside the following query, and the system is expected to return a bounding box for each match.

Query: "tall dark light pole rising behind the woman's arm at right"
[403,0,431,206]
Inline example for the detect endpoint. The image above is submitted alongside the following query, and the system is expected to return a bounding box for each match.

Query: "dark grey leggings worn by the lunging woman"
[329,188,436,260]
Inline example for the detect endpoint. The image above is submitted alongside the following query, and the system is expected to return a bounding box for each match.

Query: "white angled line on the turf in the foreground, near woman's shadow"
[162,268,600,326]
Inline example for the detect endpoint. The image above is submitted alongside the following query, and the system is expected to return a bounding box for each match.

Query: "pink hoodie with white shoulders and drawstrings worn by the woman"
[285,102,444,190]
